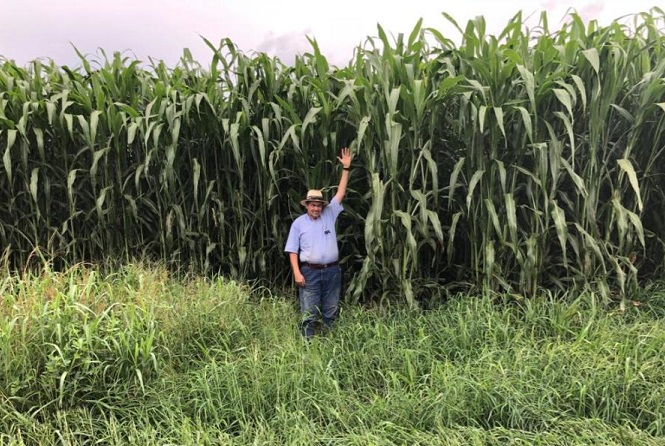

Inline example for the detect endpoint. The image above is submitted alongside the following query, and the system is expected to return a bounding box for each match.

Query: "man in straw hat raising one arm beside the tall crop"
[284,147,351,338]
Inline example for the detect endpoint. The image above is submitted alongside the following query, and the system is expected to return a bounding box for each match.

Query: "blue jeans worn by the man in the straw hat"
[298,265,342,338]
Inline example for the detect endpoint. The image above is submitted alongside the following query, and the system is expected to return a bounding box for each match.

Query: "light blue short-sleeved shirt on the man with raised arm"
[284,198,344,263]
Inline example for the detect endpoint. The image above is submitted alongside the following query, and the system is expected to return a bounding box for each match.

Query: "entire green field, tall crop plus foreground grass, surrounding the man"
[0,8,665,446]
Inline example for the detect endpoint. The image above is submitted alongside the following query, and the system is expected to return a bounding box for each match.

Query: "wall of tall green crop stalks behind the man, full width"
[0,9,665,305]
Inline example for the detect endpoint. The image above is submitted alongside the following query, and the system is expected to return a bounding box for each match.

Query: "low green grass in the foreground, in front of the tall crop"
[0,264,665,445]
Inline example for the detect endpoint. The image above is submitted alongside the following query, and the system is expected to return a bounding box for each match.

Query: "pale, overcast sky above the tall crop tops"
[0,0,658,67]
